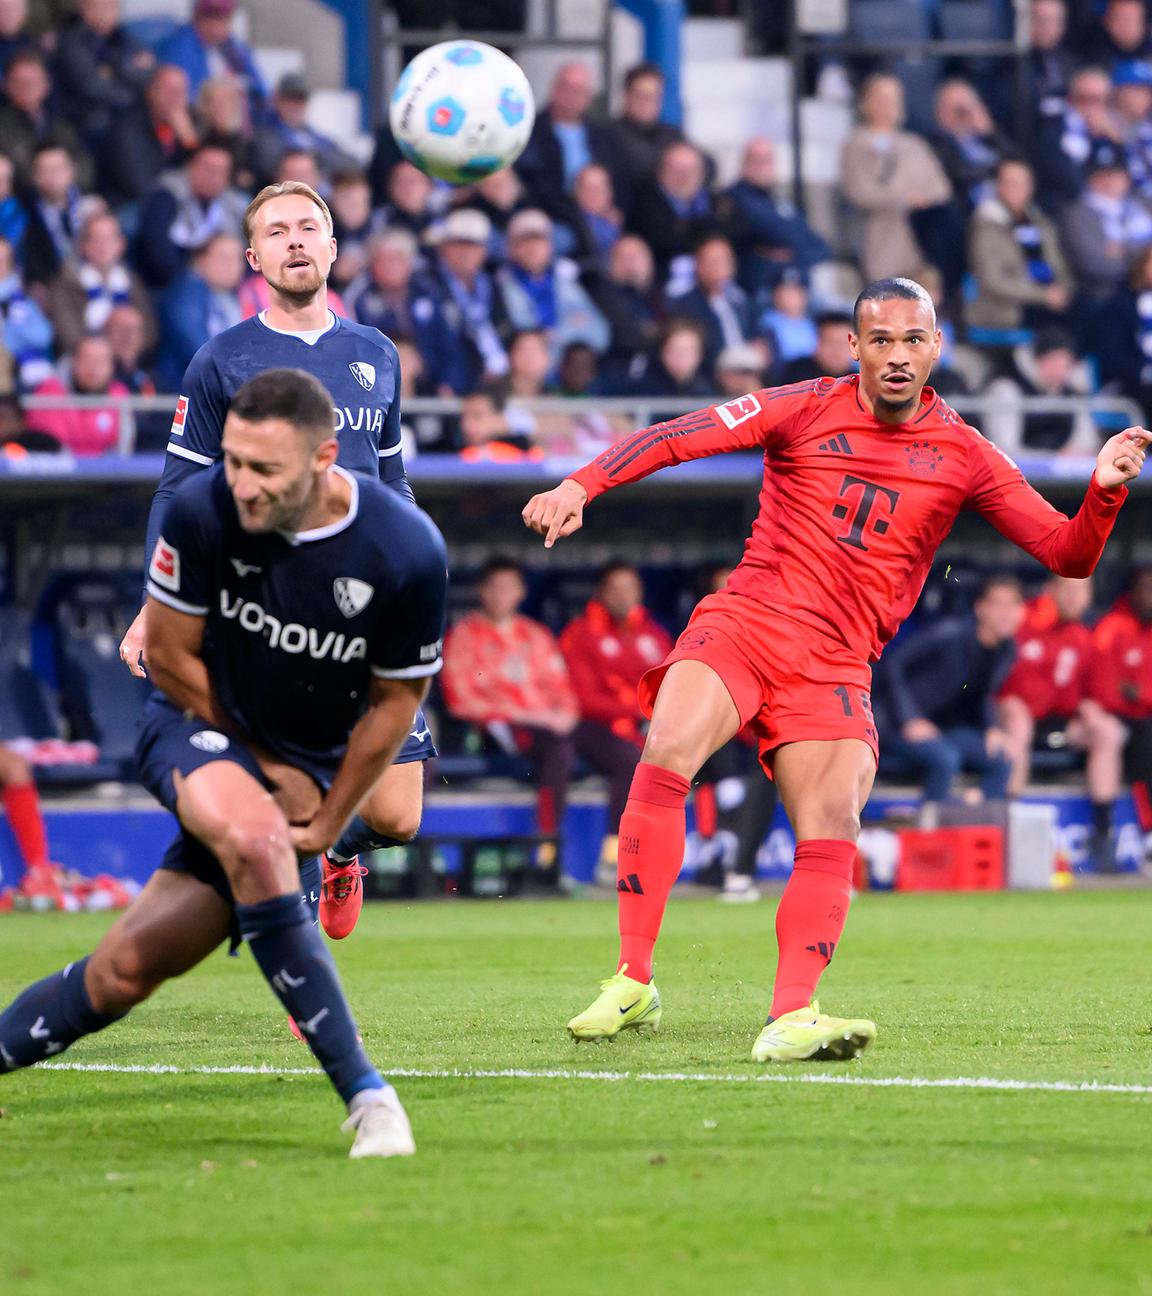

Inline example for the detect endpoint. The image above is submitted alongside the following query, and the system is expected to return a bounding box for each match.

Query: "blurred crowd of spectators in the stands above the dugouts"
[0,0,1152,457]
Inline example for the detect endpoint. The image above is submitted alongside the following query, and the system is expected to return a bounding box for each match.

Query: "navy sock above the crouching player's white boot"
[236,892,385,1103]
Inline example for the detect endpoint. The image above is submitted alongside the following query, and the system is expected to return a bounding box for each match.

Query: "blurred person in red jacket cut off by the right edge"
[1090,566,1152,863]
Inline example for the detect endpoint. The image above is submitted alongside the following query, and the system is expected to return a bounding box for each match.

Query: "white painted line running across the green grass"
[29,1061,1152,1095]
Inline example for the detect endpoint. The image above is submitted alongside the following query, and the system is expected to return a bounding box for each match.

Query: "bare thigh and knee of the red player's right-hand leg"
[772,737,876,841]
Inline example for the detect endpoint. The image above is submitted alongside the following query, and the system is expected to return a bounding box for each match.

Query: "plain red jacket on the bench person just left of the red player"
[560,599,673,740]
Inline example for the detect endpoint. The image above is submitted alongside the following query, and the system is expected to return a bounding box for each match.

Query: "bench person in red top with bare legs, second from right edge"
[999,575,1126,872]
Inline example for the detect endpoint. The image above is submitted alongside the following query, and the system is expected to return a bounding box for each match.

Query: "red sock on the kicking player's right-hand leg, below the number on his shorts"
[771,840,857,1017]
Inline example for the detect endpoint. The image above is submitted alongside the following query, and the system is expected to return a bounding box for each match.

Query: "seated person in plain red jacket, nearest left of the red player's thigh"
[560,562,673,885]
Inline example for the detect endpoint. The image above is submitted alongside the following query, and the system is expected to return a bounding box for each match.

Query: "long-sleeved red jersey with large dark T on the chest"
[573,375,1127,661]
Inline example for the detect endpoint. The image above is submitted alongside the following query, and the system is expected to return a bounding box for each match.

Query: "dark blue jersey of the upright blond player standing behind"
[148,315,412,567]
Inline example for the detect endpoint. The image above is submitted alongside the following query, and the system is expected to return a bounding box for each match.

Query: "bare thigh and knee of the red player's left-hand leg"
[643,660,741,779]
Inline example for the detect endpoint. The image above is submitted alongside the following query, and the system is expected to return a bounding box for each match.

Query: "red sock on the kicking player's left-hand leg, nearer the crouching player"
[616,761,689,981]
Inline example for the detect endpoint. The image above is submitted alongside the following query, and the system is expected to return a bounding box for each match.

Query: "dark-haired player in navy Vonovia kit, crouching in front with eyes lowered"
[0,369,447,1157]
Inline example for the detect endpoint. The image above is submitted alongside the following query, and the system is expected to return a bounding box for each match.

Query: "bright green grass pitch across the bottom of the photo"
[0,890,1152,1296]
